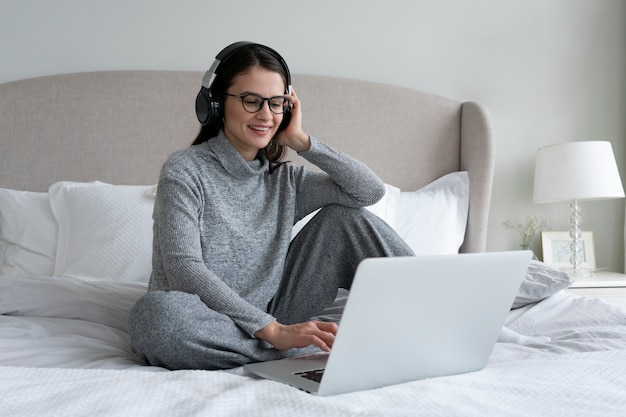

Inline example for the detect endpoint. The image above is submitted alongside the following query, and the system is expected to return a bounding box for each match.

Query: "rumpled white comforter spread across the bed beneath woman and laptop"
[0,277,626,417]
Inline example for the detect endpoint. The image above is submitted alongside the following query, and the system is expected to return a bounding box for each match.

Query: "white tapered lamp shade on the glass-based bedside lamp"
[533,141,624,203]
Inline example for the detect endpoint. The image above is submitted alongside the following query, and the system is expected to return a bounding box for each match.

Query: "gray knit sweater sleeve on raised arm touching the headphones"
[296,137,385,218]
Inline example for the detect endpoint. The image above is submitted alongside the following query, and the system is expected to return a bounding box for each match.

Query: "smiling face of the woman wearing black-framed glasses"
[224,67,285,161]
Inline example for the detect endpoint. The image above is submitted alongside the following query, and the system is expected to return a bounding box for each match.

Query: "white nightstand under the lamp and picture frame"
[567,271,626,309]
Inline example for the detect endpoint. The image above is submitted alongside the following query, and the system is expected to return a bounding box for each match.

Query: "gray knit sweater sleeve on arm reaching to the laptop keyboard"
[150,171,274,336]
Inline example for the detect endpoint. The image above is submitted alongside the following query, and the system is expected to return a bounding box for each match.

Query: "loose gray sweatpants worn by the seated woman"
[129,205,413,369]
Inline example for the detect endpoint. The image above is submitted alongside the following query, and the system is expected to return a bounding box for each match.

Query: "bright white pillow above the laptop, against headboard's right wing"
[387,171,470,255]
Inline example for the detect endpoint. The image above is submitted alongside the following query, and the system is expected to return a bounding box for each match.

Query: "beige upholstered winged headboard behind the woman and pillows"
[0,71,494,252]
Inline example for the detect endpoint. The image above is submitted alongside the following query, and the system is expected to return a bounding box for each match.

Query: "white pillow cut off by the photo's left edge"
[0,189,57,276]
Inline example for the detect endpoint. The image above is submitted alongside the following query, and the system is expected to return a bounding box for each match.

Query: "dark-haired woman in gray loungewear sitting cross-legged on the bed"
[129,43,412,369]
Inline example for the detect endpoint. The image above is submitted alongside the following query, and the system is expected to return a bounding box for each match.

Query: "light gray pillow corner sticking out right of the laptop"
[511,260,574,309]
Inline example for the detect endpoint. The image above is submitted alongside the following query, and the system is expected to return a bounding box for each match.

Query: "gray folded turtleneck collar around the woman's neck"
[206,130,269,179]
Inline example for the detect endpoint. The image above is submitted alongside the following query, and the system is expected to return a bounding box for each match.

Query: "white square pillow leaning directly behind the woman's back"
[48,181,154,282]
